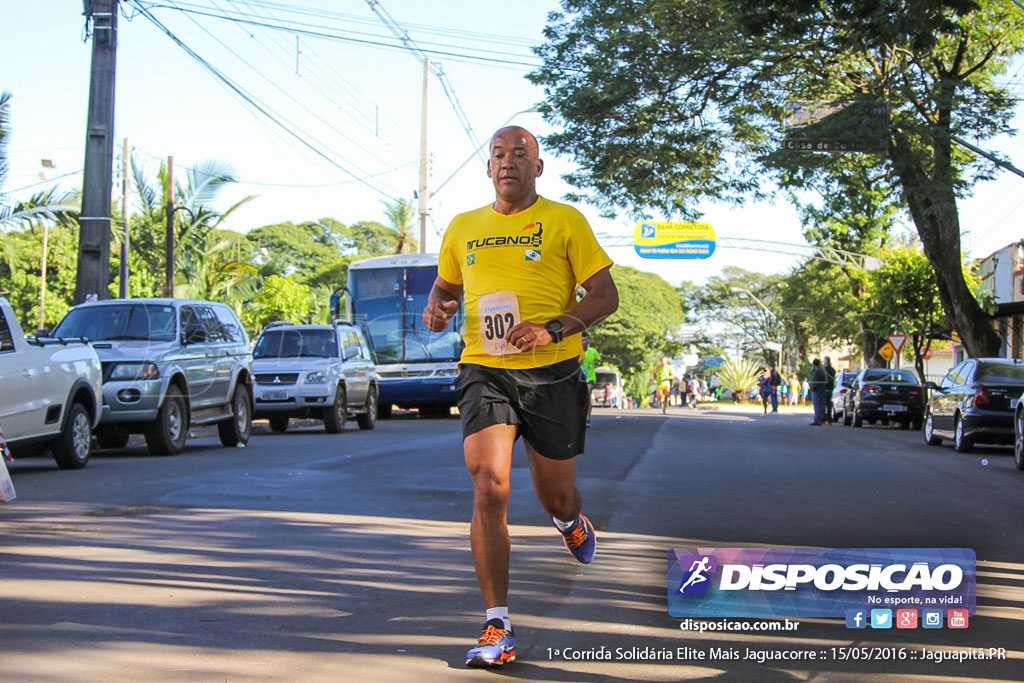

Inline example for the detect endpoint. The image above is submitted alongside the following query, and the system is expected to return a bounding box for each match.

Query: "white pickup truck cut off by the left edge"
[0,297,103,469]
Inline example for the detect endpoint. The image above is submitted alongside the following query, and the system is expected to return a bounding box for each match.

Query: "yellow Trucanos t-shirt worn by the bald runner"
[437,197,611,370]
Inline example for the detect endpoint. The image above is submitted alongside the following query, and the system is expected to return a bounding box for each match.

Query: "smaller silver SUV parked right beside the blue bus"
[253,321,377,434]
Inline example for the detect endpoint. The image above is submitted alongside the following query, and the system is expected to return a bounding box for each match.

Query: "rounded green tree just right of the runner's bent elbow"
[590,265,684,398]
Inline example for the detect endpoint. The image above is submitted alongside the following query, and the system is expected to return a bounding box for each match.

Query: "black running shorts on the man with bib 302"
[455,358,587,460]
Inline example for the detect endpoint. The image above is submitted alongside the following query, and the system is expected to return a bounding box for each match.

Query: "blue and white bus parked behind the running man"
[331,254,465,418]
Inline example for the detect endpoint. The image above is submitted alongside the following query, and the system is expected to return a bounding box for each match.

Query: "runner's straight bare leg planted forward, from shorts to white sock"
[463,425,516,608]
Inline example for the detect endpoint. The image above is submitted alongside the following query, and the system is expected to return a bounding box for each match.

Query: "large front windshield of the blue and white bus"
[348,265,462,364]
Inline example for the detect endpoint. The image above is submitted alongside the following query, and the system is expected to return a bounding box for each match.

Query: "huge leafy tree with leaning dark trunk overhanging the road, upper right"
[530,0,1024,355]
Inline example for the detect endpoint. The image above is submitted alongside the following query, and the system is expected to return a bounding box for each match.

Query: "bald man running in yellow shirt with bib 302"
[423,126,618,667]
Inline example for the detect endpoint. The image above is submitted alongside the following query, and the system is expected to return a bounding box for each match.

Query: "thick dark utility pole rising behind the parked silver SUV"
[75,0,118,304]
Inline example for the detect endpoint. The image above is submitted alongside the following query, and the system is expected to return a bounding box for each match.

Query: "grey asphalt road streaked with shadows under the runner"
[0,407,1024,681]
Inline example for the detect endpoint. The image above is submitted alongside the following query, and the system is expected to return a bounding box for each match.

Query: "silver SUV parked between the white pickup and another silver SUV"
[53,299,252,455]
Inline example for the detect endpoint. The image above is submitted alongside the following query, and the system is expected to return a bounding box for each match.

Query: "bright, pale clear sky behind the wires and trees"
[0,0,1024,284]
